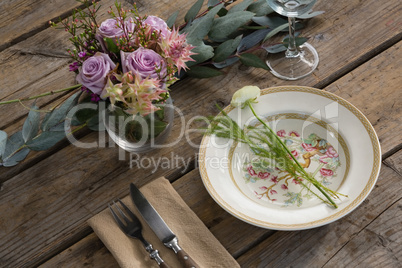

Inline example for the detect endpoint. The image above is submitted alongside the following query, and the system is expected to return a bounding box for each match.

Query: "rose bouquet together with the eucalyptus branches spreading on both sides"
[0,0,322,166]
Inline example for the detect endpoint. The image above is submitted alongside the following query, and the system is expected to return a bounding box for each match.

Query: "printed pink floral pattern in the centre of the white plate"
[243,129,341,207]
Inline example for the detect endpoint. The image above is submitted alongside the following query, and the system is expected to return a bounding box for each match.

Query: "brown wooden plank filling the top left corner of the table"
[0,0,80,51]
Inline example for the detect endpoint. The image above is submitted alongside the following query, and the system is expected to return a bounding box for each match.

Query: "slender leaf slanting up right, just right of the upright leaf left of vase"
[41,92,81,131]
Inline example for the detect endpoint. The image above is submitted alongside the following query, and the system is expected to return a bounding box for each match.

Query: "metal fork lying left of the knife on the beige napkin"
[108,199,169,268]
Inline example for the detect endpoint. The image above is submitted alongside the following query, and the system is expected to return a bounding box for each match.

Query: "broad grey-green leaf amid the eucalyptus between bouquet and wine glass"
[208,11,254,42]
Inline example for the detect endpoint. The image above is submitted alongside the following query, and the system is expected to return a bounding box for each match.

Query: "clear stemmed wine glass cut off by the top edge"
[266,0,319,80]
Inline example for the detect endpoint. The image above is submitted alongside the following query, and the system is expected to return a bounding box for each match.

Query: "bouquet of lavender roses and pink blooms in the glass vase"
[57,2,194,115]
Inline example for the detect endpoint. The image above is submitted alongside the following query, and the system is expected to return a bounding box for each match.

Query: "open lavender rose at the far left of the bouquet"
[76,52,116,95]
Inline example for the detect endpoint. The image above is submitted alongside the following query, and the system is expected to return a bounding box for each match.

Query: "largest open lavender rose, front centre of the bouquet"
[120,47,166,79]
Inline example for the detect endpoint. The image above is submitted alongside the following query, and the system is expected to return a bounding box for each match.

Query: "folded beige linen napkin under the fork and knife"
[88,177,240,268]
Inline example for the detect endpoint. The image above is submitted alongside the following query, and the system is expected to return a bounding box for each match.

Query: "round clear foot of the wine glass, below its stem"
[266,43,319,80]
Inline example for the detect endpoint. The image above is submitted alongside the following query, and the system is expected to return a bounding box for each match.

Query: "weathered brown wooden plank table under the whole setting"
[0,0,402,267]
